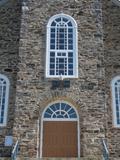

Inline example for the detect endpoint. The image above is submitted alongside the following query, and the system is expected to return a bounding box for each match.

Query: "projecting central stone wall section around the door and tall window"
[14,0,105,159]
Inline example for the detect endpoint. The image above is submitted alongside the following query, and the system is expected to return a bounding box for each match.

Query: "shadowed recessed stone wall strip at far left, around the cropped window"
[0,0,21,155]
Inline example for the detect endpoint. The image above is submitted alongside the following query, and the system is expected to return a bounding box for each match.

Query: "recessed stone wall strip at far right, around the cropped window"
[103,0,120,160]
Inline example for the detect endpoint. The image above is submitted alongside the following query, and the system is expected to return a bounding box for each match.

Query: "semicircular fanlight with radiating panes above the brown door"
[43,102,78,120]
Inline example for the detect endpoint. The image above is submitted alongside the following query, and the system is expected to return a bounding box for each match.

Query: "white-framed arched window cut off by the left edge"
[0,74,9,126]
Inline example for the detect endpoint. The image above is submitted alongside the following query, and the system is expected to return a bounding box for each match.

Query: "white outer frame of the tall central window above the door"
[45,13,78,79]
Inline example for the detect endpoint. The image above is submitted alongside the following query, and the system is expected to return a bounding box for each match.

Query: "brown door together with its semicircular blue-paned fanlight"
[42,102,79,157]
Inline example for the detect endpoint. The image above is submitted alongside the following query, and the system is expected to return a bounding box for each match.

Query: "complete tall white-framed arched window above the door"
[46,14,78,78]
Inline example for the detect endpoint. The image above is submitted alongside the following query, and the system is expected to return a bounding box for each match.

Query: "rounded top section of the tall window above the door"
[47,13,77,27]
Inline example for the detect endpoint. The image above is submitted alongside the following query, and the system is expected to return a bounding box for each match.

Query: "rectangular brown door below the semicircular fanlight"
[42,121,78,157]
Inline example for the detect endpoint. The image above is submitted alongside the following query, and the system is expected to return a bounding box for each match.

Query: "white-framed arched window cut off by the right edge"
[111,76,120,127]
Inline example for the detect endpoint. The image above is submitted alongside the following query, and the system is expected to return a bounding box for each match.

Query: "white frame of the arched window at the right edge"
[111,76,120,128]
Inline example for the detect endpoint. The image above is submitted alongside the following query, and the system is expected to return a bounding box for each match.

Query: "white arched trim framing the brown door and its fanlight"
[40,100,80,158]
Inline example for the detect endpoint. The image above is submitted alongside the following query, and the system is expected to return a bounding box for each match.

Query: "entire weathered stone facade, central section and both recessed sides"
[0,0,120,160]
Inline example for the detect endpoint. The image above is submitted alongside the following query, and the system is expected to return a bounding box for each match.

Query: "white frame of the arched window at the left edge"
[0,74,10,127]
